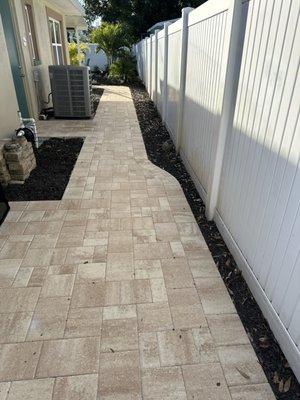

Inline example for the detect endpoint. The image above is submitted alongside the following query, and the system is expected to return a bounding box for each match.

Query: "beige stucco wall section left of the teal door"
[0,15,19,139]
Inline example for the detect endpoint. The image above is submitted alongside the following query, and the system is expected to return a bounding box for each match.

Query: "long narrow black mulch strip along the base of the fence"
[131,84,300,400]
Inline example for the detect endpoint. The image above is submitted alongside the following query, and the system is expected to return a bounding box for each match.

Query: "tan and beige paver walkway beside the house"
[0,87,273,400]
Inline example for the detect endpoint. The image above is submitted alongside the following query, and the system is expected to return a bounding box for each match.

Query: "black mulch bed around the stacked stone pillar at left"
[5,138,84,201]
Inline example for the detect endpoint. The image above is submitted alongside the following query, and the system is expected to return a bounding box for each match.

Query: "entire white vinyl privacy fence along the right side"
[135,0,300,380]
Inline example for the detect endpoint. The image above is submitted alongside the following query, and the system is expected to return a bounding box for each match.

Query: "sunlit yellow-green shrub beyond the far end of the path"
[91,22,130,65]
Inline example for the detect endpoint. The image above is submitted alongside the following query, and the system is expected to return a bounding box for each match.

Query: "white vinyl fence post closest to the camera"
[206,0,246,220]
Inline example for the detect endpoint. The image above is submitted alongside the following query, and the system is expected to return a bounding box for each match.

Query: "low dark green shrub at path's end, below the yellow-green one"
[109,51,137,83]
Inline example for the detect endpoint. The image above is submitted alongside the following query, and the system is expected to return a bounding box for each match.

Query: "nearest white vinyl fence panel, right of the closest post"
[218,0,300,377]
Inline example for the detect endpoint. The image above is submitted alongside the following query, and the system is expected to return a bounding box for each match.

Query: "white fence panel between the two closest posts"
[181,1,231,196]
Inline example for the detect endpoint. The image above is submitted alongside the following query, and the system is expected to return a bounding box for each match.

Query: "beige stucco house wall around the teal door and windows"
[0,0,70,131]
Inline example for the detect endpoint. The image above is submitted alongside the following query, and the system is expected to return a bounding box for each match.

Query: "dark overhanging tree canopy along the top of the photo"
[85,0,206,41]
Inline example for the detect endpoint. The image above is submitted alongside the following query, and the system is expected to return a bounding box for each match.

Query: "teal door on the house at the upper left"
[0,0,29,117]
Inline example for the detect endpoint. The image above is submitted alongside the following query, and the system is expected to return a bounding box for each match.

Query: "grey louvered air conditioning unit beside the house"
[49,65,93,118]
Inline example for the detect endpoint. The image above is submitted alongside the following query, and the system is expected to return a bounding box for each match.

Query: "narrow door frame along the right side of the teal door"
[7,0,34,118]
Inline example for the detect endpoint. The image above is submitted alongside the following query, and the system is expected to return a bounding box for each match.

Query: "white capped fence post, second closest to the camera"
[176,7,193,153]
